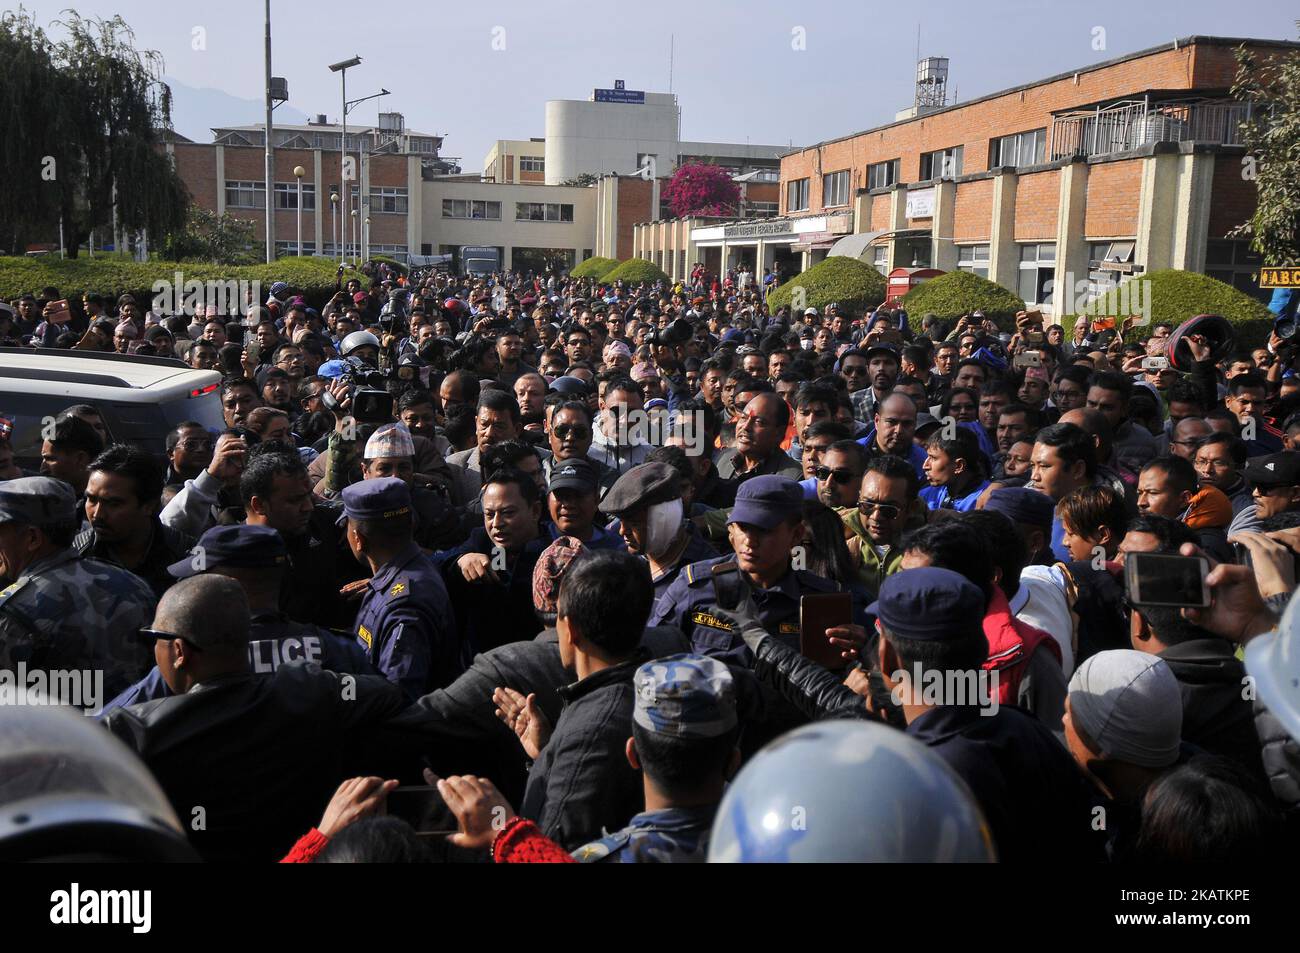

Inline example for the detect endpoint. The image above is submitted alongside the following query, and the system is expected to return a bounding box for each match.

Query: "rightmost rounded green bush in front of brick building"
[1060,268,1273,348]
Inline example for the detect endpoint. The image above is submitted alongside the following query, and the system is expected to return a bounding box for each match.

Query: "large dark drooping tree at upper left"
[0,8,189,256]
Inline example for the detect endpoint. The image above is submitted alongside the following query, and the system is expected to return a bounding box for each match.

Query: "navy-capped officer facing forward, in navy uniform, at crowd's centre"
[655,475,865,666]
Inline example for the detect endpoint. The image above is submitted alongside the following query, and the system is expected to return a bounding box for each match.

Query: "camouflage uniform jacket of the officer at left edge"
[0,549,155,698]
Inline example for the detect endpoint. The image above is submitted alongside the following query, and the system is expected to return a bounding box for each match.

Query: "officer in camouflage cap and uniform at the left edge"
[0,477,155,707]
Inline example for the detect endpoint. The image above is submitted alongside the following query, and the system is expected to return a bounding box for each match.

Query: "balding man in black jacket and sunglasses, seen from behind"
[104,573,406,861]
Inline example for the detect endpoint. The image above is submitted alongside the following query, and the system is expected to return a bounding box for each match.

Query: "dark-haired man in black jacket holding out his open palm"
[495,550,654,850]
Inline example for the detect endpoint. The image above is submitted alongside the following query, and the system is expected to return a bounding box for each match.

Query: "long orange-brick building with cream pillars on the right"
[634,36,1300,313]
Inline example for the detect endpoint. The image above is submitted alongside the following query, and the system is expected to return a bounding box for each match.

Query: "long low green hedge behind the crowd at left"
[0,256,369,307]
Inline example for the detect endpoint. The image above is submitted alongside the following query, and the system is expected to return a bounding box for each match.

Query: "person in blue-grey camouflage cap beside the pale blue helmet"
[573,655,740,863]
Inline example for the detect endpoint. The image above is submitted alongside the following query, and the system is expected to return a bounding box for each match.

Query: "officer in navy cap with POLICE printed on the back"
[94,523,374,714]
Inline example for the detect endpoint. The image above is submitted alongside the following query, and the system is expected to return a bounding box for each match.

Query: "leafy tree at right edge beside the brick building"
[1230,29,1300,267]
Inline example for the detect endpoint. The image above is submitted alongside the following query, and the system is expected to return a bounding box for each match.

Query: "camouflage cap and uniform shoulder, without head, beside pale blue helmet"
[573,655,737,863]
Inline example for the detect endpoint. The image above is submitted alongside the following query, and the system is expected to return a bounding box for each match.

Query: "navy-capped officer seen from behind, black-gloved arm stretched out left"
[711,567,1101,861]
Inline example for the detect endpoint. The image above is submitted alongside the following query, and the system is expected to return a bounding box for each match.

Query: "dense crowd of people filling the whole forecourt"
[0,260,1300,862]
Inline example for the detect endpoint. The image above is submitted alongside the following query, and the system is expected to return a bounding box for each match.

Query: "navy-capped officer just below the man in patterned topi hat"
[342,477,464,698]
